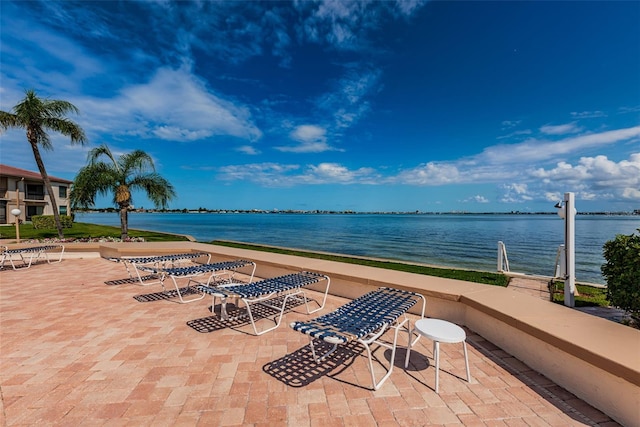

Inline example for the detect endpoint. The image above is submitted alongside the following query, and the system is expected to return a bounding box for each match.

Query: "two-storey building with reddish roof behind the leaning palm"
[0,164,73,224]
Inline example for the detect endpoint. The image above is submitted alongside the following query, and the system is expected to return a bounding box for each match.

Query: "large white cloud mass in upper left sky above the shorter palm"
[75,67,262,141]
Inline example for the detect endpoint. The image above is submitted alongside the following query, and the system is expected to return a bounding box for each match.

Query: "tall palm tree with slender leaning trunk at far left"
[0,89,87,239]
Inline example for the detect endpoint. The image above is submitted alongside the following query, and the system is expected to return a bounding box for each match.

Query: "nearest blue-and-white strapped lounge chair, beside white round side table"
[291,288,426,390]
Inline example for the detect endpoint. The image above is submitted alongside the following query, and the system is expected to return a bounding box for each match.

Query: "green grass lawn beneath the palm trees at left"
[0,222,188,242]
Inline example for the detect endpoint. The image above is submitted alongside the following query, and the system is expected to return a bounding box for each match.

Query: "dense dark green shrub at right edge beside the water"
[601,229,640,318]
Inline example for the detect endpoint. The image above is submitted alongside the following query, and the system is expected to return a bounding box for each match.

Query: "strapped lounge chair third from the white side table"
[137,260,256,304]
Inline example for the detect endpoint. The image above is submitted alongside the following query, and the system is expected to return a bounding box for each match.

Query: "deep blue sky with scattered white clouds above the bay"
[0,1,640,212]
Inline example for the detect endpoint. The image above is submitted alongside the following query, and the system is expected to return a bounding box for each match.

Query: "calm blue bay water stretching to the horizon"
[76,213,640,283]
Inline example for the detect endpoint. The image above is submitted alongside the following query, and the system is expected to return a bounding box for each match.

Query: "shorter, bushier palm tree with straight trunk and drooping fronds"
[71,145,176,240]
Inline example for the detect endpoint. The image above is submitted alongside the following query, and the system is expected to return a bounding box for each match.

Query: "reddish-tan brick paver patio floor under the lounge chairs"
[0,258,617,427]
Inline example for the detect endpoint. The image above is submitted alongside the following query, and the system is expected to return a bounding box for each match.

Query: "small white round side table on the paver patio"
[404,319,471,393]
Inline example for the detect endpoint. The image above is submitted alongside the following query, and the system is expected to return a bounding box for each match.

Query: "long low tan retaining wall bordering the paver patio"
[18,242,640,426]
